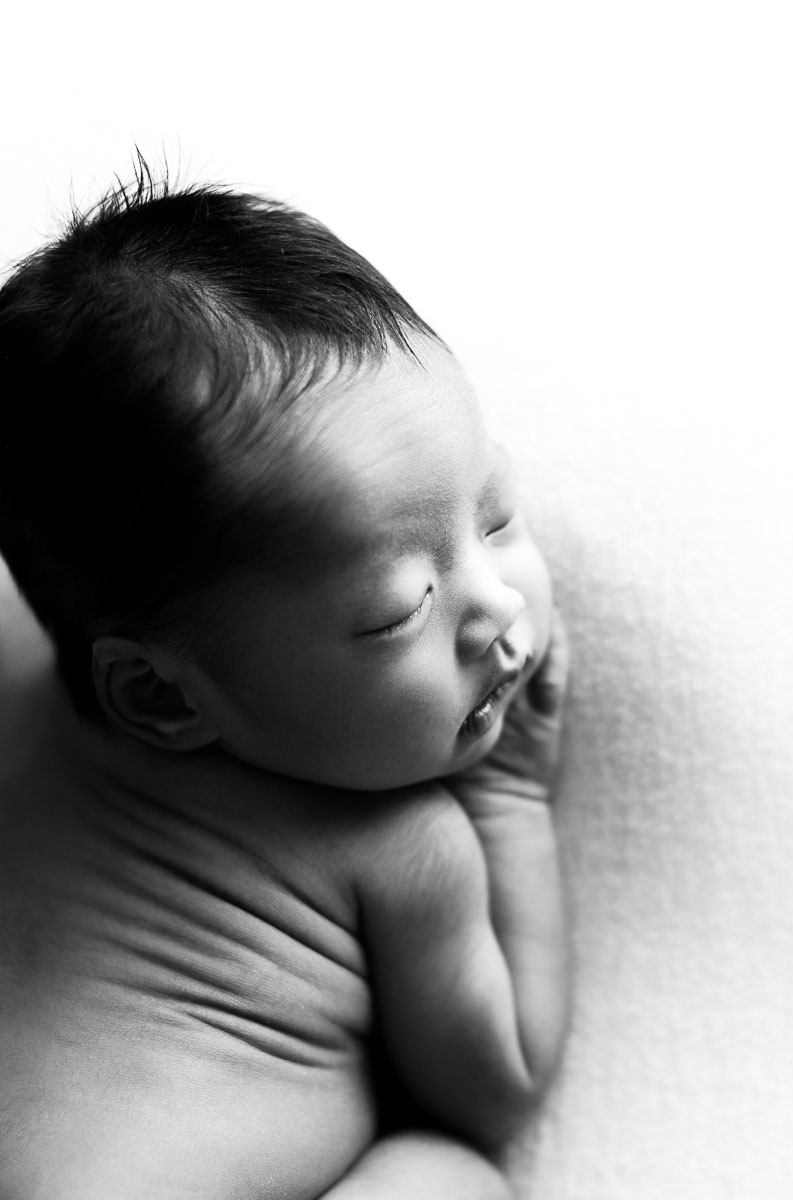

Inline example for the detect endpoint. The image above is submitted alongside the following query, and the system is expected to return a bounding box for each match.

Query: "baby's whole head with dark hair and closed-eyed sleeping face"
[0,169,551,788]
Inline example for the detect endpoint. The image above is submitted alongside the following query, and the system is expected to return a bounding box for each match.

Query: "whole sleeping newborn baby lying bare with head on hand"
[0,175,567,1200]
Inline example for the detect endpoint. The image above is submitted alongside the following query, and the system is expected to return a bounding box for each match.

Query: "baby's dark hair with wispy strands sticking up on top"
[0,163,435,714]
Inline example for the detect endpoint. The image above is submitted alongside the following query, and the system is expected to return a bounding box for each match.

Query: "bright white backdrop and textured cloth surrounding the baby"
[0,0,793,1200]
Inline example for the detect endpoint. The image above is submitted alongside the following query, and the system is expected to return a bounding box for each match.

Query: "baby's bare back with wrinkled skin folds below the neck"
[0,672,381,1200]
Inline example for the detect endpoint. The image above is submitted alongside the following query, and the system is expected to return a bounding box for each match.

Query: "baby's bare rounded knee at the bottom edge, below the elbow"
[322,1130,513,1200]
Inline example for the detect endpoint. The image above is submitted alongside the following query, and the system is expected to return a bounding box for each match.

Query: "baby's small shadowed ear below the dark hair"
[94,637,217,750]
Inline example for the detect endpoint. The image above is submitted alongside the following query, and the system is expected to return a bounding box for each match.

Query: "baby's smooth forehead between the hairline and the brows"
[223,340,493,580]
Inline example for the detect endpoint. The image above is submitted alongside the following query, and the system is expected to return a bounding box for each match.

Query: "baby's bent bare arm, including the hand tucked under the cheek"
[361,619,567,1151]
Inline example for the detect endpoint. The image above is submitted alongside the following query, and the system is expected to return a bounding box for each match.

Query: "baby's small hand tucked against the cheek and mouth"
[444,612,569,817]
